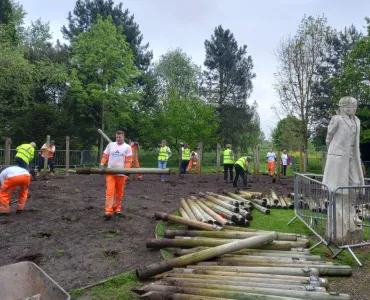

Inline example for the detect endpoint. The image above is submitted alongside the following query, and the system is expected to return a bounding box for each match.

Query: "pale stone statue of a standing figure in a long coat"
[323,97,364,244]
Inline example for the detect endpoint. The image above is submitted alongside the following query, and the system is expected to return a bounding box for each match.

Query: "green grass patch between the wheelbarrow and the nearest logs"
[69,271,140,300]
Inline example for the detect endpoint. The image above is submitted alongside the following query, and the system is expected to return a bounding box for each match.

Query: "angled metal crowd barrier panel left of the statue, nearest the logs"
[288,174,334,253]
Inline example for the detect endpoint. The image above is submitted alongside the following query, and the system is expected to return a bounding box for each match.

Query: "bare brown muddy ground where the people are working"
[0,174,365,299]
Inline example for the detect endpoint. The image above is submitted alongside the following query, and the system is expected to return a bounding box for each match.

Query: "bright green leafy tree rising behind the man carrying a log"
[72,16,140,150]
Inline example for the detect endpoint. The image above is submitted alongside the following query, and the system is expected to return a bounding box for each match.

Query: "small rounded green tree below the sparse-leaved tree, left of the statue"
[271,115,304,150]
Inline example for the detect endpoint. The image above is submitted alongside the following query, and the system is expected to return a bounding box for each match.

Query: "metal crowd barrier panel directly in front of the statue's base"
[332,184,370,266]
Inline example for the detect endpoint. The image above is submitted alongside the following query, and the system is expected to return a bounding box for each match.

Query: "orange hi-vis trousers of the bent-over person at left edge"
[0,174,31,214]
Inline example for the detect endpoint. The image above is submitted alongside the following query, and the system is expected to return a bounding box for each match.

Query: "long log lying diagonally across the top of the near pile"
[136,232,276,280]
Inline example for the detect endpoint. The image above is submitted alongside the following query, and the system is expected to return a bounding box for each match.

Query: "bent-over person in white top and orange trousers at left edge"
[0,166,31,216]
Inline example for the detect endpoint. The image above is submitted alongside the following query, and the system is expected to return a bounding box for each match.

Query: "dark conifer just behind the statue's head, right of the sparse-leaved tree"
[312,25,361,147]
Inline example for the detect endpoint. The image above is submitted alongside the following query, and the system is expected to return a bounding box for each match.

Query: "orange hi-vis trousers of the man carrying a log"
[105,174,126,215]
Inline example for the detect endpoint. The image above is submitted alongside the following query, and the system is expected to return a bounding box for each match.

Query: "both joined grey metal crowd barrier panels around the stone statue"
[288,173,370,266]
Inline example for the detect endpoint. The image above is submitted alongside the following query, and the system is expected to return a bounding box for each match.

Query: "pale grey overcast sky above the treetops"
[19,0,370,137]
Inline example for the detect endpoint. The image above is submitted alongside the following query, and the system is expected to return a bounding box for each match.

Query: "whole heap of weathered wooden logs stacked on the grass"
[134,192,352,300]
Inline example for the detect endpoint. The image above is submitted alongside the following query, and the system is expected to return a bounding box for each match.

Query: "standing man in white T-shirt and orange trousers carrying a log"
[100,131,132,220]
